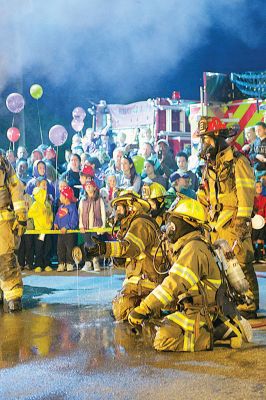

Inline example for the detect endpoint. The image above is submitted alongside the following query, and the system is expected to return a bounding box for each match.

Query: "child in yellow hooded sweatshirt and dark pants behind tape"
[28,183,53,272]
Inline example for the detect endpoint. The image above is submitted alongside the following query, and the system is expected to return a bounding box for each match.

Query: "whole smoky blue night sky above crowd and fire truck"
[0,0,266,150]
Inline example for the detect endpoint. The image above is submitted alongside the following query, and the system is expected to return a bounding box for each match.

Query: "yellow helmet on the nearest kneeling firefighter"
[168,195,210,230]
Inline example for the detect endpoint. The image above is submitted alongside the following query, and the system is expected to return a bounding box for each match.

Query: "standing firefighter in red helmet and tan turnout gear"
[198,117,259,318]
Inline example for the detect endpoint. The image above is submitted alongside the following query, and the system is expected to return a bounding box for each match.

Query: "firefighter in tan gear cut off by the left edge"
[0,155,27,312]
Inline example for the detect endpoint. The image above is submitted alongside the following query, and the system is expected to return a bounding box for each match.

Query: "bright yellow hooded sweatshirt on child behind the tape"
[28,187,53,230]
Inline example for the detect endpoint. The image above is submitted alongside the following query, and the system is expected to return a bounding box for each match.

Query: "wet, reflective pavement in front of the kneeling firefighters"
[0,270,266,400]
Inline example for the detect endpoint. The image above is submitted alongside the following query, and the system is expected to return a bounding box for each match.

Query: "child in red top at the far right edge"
[252,181,266,263]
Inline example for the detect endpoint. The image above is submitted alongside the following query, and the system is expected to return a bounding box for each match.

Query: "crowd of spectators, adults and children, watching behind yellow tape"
[1,122,266,272]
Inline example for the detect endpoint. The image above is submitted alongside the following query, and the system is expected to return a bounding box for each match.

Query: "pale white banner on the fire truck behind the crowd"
[108,101,154,129]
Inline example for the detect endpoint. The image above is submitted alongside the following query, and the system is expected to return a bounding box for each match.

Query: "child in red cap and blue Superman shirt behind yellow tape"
[54,186,78,272]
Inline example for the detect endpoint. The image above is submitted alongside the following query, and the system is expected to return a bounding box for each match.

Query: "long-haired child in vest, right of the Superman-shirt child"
[79,179,106,272]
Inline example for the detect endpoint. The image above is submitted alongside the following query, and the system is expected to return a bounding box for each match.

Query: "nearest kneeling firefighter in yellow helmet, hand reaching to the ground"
[128,197,252,352]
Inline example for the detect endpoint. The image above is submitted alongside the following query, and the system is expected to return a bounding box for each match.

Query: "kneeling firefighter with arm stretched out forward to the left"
[86,190,168,321]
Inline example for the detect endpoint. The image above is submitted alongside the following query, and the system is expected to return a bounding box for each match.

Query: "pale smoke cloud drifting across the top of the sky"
[0,0,263,97]
